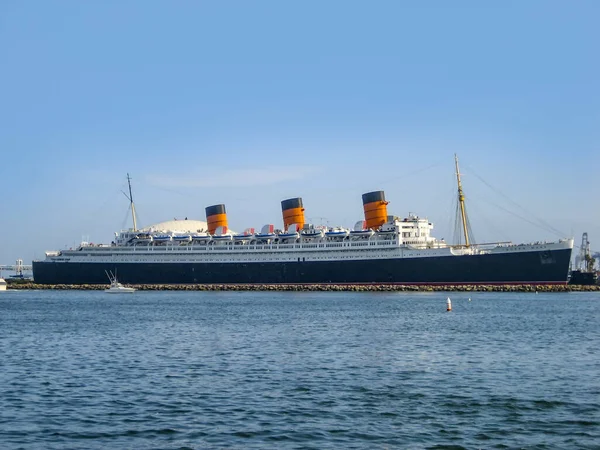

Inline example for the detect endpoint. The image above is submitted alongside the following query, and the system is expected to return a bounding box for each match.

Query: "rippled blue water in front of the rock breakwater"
[0,291,600,449]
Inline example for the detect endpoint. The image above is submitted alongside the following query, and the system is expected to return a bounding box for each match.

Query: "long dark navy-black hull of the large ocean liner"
[33,249,571,284]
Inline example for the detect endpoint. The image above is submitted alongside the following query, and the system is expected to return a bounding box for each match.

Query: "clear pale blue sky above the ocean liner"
[0,0,600,264]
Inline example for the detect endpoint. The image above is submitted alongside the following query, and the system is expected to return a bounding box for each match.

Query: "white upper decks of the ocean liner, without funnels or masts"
[46,214,573,263]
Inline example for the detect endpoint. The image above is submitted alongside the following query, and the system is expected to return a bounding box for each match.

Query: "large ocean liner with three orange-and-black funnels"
[32,155,573,285]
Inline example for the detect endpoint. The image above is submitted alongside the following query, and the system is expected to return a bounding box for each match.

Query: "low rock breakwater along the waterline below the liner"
[7,282,600,292]
